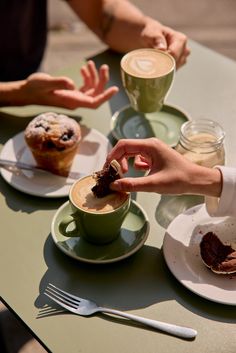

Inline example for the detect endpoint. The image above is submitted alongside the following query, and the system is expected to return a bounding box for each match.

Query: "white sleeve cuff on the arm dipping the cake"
[205,166,236,217]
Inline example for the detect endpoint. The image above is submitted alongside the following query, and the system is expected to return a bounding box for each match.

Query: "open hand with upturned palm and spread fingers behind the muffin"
[22,60,118,109]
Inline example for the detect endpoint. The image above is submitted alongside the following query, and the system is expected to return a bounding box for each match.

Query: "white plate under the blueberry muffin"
[0,126,111,198]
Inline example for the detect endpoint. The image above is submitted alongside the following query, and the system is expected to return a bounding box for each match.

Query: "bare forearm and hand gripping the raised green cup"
[68,0,190,68]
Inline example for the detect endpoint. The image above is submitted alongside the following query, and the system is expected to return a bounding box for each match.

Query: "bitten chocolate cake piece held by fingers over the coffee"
[92,160,122,198]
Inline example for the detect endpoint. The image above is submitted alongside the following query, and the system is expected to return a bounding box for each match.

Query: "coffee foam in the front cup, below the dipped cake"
[71,176,129,213]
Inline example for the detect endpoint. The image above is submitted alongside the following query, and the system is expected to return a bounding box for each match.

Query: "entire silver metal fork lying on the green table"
[44,283,197,339]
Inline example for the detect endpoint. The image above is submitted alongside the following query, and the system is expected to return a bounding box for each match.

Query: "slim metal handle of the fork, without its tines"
[99,307,197,338]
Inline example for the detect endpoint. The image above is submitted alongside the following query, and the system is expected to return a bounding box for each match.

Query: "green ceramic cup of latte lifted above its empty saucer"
[121,48,175,113]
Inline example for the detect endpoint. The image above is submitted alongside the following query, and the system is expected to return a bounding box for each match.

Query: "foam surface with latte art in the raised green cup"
[121,49,174,78]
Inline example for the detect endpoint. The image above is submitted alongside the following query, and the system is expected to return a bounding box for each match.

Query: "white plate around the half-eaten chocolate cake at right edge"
[163,205,236,305]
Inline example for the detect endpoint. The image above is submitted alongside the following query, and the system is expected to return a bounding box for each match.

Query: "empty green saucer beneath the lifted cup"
[111,104,189,147]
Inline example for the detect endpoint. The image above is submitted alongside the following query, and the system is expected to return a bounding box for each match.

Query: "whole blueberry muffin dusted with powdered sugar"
[25,112,81,176]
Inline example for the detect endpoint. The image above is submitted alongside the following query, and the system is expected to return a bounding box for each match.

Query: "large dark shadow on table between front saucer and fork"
[35,230,236,323]
